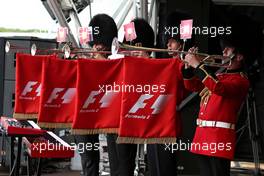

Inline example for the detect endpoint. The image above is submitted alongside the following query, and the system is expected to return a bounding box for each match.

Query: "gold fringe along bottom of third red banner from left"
[71,128,118,135]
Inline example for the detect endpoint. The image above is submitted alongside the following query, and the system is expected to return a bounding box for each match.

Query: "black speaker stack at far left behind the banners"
[0,37,57,166]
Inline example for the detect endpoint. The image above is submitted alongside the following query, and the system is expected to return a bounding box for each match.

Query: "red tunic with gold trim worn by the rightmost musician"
[184,65,249,160]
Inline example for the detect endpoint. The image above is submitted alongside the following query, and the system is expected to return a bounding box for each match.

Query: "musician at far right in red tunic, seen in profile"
[182,16,260,176]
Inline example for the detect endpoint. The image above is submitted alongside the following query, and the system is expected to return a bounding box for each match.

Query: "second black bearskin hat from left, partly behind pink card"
[124,18,154,48]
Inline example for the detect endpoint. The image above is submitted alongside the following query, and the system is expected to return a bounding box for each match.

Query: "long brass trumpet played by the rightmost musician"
[111,38,235,67]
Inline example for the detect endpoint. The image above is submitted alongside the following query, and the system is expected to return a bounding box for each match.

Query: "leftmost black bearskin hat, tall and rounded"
[89,14,117,49]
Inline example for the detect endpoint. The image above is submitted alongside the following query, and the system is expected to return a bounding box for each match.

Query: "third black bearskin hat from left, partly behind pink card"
[163,11,191,43]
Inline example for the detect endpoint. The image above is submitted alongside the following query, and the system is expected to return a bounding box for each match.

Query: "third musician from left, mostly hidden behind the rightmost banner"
[147,11,190,176]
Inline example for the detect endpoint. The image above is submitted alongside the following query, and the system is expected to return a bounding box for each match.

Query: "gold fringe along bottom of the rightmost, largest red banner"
[117,137,177,144]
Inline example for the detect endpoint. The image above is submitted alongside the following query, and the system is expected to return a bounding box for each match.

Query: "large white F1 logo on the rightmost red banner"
[129,94,170,114]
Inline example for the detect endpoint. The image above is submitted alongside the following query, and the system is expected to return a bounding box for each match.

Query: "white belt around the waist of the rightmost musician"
[196,119,235,130]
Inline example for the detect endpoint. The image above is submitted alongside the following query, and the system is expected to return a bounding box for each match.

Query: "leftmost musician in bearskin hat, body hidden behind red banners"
[75,14,118,176]
